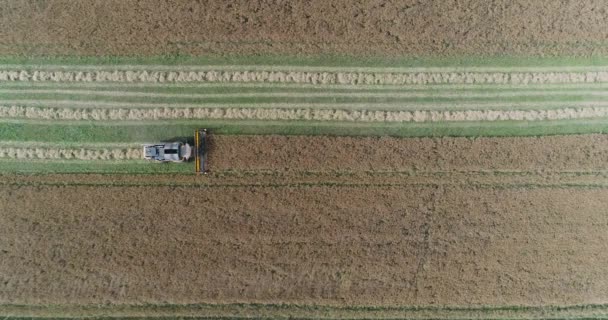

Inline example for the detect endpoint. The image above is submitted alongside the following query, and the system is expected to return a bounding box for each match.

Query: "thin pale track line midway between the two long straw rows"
[5,89,608,99]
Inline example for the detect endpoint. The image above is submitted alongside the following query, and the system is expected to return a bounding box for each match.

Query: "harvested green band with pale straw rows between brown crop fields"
[0,58,608,172]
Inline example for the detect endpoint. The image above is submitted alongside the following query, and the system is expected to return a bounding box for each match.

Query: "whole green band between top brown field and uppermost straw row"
[0,54,608,71]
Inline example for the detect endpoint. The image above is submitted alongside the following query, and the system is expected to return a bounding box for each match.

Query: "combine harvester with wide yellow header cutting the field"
[143,129,207,174]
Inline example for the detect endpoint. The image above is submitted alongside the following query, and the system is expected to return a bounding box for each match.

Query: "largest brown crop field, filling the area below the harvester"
[0,182,608,305]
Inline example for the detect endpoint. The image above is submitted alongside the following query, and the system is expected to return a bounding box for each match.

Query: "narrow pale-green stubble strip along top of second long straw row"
[5,99,608,111]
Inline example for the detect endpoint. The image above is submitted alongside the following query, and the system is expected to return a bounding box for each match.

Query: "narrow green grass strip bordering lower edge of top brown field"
[0,55,608,68]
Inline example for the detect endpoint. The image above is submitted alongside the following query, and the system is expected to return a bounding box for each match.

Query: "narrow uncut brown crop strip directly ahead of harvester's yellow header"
[209,135,608,171]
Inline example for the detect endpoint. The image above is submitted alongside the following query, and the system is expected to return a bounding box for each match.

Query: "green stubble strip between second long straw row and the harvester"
[0,119,608,143]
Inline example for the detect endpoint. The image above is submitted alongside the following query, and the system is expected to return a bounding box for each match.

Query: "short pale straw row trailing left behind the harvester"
[0,147,142,160]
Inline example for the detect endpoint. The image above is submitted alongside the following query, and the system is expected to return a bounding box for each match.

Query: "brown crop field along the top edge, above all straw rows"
[0,0,608,56]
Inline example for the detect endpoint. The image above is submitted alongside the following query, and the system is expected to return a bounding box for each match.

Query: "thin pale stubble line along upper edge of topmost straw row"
[0,64,608,73]
